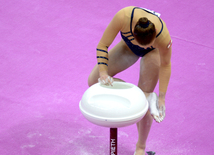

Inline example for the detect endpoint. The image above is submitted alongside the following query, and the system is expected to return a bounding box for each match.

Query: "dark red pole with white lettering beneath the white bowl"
[110,128,117,155]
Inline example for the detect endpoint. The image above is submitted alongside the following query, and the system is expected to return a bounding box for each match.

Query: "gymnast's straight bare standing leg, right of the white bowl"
[135,49,160,155]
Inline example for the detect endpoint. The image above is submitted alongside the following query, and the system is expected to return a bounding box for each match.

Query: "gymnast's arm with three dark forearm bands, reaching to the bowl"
[97,10,124,84]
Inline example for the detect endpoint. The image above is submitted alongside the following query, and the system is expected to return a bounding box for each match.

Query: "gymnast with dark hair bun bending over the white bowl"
[88,6,172,155]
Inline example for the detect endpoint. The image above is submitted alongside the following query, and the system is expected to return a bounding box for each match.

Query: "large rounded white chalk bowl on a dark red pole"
[79,82,148,128]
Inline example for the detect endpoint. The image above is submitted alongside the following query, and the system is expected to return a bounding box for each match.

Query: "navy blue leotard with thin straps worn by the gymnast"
[120,7,163,57]
